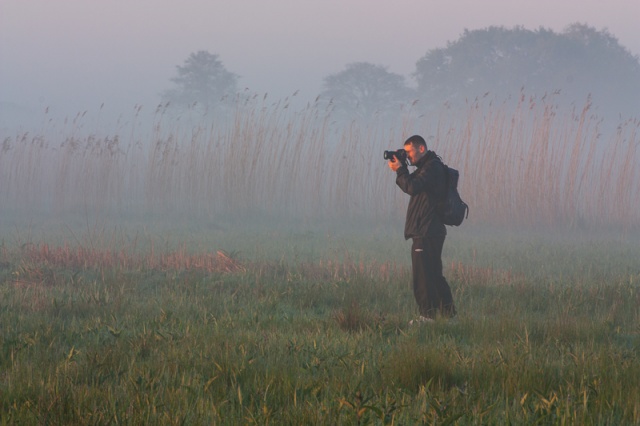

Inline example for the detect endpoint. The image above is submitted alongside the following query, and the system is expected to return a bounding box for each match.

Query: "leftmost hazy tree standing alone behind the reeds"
[162,50,238,109]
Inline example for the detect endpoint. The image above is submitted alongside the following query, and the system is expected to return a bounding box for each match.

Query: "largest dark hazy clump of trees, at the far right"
[413,24,640,119]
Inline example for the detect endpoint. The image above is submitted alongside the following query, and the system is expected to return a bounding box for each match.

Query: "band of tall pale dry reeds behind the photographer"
[0,94,640,229]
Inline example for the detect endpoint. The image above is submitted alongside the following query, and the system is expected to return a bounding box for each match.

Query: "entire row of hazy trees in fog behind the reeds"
[162,23,640,124]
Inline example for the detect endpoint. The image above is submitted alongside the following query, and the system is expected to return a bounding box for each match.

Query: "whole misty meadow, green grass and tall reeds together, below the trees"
[0,98,640,425]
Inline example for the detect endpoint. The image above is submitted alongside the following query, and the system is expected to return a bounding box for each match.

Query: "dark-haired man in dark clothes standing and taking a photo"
[389,135,456,323]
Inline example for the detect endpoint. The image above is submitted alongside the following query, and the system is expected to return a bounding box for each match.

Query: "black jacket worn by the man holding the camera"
[396,151,447,240]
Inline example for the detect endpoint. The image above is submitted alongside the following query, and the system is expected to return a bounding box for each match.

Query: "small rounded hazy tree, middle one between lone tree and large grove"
[320,62,412,124]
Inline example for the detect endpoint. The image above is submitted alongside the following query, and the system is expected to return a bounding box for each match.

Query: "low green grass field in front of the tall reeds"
[0,230,640,425]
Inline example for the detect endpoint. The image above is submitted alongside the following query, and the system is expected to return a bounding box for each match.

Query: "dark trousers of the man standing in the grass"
[411,237,456,318]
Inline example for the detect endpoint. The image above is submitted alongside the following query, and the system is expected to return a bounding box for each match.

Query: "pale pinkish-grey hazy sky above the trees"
[0,0,640,126]
